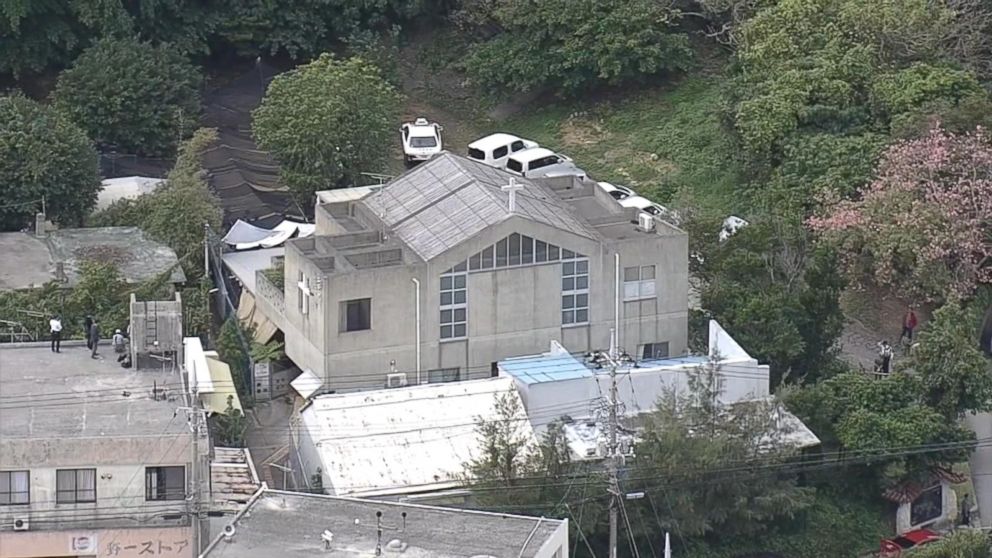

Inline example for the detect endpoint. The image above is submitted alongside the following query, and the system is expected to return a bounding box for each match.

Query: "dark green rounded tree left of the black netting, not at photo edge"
[54,38,201,156]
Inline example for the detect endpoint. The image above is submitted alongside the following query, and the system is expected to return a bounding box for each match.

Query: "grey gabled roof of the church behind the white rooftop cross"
[361,153,599,260]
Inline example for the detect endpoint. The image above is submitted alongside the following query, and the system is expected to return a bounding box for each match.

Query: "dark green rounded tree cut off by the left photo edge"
[0,95,100,231]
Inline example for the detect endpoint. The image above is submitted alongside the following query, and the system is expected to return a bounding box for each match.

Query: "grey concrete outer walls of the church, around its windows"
[276,219,688,391]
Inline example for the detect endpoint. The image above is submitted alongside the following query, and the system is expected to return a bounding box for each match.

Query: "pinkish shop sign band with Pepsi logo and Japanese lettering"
[0,527,195,558]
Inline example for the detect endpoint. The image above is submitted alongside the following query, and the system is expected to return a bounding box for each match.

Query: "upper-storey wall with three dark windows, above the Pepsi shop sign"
[0,434,191,531]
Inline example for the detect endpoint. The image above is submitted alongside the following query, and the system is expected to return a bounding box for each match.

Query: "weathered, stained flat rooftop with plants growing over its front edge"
[0,227,186,290]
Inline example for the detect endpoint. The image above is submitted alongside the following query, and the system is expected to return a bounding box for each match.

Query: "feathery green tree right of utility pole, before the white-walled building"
[625,358,812,538]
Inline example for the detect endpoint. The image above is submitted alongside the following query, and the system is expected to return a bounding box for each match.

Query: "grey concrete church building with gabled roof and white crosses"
[241,153,688,391]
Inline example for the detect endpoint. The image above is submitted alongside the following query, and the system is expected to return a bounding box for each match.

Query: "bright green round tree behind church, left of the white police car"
[252,54,400,205]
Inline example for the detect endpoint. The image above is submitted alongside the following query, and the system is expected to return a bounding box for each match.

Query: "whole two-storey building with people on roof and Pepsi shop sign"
[0,343,195,558]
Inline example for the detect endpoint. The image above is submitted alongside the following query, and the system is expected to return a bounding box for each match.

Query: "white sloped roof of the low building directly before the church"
[300,377,534,496]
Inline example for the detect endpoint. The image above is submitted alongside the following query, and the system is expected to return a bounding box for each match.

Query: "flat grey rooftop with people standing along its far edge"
[0,343,186,439]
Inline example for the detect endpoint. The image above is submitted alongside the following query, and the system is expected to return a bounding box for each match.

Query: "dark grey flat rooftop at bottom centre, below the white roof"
[203,490,563,558]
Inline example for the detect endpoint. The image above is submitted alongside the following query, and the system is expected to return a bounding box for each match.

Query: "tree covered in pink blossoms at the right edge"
[809,128,992,300]
